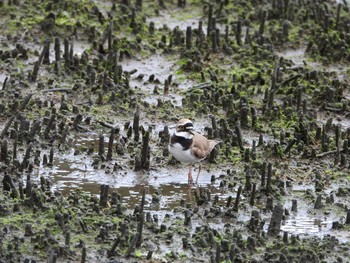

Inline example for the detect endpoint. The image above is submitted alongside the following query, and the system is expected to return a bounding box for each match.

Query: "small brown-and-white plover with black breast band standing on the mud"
[169,119,220,184]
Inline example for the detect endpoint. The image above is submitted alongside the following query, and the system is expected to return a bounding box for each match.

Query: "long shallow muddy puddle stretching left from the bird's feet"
[39,152,219,193]
